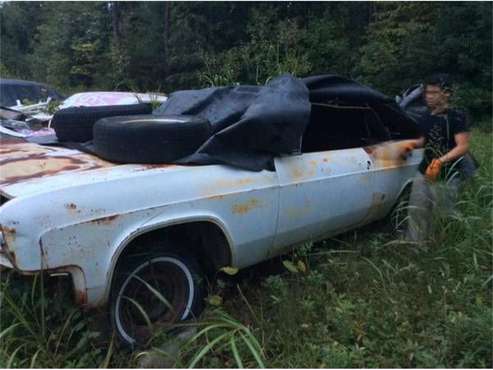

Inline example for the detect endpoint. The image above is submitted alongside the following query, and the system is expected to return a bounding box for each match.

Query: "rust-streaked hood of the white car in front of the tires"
[0,137,184,199]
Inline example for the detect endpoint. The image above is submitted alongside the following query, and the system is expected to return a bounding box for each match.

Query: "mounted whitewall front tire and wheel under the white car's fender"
[110,252,204,348]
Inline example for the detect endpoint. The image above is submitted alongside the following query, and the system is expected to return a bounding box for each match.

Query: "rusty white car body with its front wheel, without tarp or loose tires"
[0,96,422,345]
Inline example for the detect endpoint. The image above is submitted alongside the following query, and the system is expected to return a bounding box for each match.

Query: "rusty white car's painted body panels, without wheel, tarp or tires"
[0,135,422,307]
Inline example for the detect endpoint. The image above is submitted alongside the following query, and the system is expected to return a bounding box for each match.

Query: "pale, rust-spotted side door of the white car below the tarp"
[274,148,373,253]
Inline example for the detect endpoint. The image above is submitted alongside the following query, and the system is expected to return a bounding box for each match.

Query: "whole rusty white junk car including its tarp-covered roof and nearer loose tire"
[0,75,422,345]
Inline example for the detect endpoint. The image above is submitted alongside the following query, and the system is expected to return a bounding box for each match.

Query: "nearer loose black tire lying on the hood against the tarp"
[94,115,211,164]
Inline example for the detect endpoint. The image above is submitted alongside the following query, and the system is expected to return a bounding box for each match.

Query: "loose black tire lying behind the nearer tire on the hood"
[51,103,152,143]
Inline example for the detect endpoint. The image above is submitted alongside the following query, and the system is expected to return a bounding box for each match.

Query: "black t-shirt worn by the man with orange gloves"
[419,109,469,178]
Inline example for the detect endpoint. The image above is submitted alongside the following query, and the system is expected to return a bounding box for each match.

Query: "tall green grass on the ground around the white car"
[0,127,493,368]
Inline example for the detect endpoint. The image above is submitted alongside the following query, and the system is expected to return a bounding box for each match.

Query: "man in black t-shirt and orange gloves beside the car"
[406,74,474,243]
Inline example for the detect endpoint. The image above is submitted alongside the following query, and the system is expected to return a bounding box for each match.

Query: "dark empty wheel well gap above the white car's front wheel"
[116,221,232,275]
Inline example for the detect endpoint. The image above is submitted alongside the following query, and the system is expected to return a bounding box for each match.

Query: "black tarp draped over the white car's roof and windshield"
[154,74,419,171]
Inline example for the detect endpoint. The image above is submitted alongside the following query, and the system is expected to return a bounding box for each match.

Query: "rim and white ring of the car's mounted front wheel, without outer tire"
[114,257,195,344]
